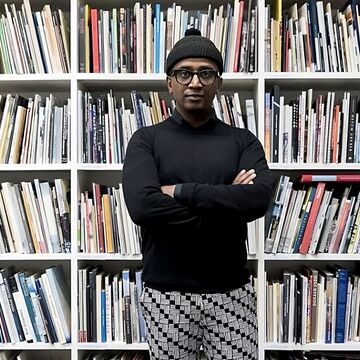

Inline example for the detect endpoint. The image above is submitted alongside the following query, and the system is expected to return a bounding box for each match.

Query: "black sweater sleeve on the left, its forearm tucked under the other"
[122,128,198,225]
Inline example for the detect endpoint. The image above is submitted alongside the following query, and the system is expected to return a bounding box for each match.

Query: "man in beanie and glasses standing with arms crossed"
[123,30,273,360]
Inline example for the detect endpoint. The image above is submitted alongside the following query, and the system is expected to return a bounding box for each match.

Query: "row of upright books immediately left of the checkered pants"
[78,266,146,344]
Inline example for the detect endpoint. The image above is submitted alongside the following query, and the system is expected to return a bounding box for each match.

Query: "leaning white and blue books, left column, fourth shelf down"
[0,266,71,344]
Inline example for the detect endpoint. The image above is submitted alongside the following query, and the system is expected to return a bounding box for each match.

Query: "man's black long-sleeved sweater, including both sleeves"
[122,111,273,293]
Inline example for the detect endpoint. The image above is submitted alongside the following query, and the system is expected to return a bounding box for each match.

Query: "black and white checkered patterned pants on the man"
[141,283,258,360]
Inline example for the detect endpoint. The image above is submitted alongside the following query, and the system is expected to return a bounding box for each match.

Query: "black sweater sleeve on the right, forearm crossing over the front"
[176,131,273,221]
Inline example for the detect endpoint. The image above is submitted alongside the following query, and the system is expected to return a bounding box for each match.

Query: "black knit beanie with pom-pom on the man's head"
[165,28,224,75]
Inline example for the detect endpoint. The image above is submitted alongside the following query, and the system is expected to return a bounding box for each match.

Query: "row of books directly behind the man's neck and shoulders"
[78,90,257,163]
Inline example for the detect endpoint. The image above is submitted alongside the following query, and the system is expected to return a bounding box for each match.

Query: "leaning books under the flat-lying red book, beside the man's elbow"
[264,175,360,254]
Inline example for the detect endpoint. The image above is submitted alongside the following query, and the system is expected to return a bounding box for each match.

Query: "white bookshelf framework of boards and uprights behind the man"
[0,0,360,360]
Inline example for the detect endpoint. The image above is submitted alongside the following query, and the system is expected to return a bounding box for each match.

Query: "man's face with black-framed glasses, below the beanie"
[167,58,222,114]
